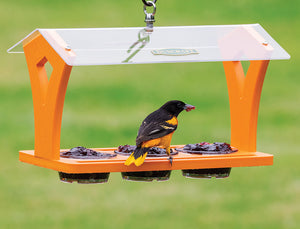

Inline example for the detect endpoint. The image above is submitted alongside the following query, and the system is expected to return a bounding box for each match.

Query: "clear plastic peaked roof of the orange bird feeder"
[8,24,290,66]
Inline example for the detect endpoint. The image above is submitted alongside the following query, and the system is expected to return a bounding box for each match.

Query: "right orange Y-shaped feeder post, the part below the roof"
[223,60,269,152]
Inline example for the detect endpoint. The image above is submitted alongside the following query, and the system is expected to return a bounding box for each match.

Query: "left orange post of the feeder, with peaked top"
[23,33,72,160]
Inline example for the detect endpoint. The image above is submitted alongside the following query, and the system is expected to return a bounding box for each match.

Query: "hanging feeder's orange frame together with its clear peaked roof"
[9,24,290,182]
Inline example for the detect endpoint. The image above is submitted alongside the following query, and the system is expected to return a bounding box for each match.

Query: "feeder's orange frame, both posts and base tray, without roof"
[19,33,273,173]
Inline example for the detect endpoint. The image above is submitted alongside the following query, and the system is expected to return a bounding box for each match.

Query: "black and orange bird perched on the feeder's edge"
[125,100,195,166]
